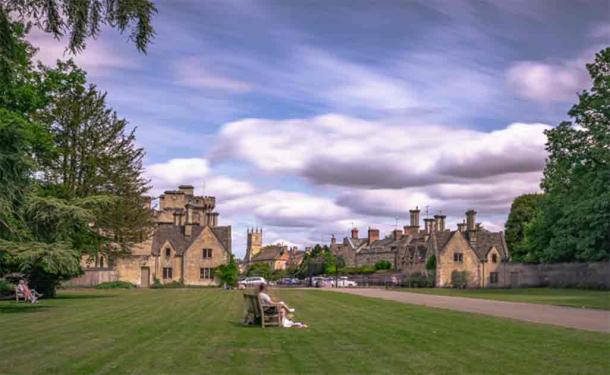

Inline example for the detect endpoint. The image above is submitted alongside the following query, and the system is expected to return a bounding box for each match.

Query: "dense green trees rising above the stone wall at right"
[506,48,610,263]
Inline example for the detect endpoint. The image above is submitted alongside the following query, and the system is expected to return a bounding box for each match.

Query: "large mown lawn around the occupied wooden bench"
[0,289,610,374]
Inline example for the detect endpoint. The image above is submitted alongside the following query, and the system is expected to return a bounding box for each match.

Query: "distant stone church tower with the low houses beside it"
[244,228,305,271]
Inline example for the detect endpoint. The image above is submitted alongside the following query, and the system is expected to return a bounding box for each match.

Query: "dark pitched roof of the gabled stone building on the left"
[151,224,231,255]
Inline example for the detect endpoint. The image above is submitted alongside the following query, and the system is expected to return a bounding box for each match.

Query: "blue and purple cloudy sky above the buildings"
[29,0,610,257]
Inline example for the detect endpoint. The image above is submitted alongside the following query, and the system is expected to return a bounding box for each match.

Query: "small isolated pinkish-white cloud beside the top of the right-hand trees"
[506,59,588,102]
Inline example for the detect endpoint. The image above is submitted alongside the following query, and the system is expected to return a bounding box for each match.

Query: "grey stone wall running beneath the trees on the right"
[501,262,610,289]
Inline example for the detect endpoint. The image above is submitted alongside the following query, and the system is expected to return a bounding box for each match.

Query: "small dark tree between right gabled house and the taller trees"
[505,194,544,261]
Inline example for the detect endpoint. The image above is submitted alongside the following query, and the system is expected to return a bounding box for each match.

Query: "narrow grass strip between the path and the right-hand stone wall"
[400,288,610,310]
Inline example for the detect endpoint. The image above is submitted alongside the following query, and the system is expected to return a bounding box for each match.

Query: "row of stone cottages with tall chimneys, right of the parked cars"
[330,208,509,287]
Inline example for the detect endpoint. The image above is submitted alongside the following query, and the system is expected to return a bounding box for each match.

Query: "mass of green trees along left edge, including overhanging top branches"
[0,0,155,296]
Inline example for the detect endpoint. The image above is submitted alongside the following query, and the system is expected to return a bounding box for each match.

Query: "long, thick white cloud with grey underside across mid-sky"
[213,115,550,188]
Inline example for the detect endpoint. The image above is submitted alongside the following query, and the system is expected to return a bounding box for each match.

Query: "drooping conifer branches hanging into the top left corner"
[0,0,157,53]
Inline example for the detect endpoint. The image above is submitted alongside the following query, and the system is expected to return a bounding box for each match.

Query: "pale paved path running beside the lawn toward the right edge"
[325,288,610,333]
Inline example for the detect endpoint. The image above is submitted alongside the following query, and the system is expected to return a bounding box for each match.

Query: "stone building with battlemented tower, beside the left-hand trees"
[114,185,231,287]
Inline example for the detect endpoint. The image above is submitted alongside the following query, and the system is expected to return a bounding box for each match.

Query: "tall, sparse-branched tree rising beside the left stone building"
[40,61,151,249]
